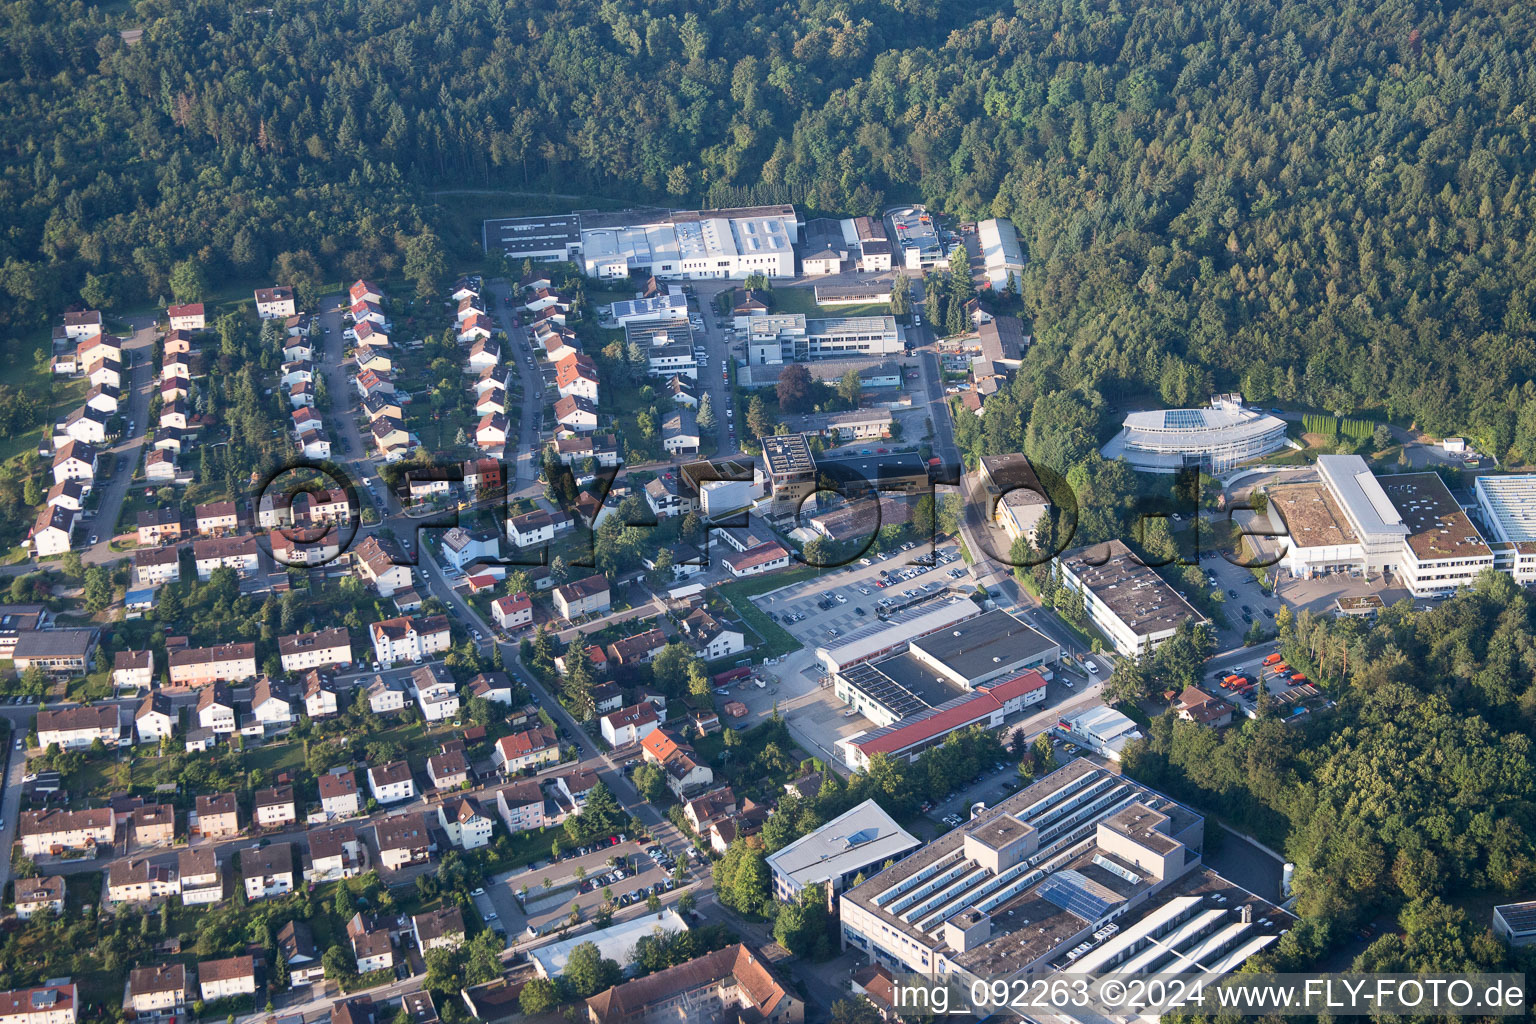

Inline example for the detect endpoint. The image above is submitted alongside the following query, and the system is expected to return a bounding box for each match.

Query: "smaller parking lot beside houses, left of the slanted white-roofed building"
[475,840,702,941]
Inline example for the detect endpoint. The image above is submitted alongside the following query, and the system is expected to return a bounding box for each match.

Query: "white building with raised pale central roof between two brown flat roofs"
[1266,454,1492,597]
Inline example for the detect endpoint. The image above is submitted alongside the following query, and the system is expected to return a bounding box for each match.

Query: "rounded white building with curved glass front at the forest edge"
[1101,395,1286,473]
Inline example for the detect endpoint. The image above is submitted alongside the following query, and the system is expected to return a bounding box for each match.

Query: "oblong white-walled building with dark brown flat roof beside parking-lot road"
[1057,540,1209,657]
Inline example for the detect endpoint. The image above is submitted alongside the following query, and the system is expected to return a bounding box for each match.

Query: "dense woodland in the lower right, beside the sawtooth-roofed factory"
[1126,570,1536,969]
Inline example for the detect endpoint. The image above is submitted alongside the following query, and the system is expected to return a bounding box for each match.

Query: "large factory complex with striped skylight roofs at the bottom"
[840,758,1290,989]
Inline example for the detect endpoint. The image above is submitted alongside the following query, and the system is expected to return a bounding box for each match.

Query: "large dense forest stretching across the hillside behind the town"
[0,0,1536,459]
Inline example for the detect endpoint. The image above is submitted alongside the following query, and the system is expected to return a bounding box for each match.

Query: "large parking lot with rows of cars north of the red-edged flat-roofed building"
[756,543,971,648]
